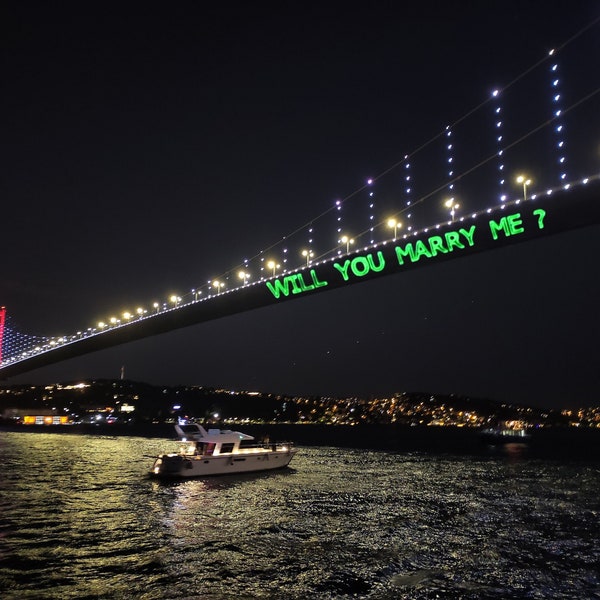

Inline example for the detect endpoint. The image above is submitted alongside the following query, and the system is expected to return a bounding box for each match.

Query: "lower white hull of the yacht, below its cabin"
[150,449,296,479]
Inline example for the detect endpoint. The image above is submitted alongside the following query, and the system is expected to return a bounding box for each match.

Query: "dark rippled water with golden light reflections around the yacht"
[0,432,600,600]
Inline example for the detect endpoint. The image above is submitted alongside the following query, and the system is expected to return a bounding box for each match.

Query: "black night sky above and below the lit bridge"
[0,0,600,406]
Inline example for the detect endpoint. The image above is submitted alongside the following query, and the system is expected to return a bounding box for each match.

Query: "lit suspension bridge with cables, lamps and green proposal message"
[0,28,600,378]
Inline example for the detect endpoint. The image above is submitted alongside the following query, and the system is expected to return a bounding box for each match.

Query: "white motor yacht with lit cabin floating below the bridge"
[150,423,296,478]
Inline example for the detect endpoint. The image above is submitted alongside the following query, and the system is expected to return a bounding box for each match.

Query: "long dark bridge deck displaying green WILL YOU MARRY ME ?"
[0,183,600,378]
